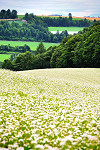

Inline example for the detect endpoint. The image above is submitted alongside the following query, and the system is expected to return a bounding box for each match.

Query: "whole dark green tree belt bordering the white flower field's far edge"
[2,23,100,71]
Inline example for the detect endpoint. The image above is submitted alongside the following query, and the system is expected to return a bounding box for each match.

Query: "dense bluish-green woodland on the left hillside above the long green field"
[0,21,68,43]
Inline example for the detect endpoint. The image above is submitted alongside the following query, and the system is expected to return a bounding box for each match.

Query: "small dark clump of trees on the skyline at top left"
[0,9,18,19]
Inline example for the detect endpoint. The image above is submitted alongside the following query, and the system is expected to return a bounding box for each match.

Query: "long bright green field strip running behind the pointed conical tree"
[0,41,58,51]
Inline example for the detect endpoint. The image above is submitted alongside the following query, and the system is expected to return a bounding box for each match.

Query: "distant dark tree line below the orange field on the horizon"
[24,13,93,27]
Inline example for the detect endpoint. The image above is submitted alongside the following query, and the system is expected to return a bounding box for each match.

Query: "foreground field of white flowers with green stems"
[0,68,100,150]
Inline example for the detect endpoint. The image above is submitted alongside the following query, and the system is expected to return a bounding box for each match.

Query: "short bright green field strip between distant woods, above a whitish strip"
[48,27,84,31]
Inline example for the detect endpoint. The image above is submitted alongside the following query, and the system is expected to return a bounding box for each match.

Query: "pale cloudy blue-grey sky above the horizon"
[0,0,100,17]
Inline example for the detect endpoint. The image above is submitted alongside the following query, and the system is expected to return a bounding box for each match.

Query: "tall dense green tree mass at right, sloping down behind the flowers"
[50,23,100,67]
